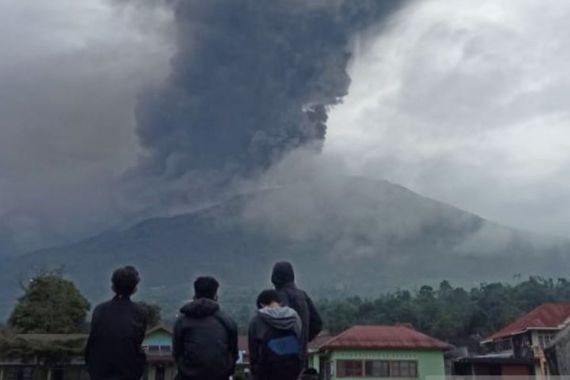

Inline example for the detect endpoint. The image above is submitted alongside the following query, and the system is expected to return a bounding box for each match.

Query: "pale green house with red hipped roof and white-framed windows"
[310,326,451,380]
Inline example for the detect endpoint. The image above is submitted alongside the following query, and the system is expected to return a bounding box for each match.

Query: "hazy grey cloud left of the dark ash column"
[0,0,171,253]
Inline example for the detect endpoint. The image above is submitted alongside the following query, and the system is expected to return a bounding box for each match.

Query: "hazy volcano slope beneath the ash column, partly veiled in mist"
[0,178,568,314]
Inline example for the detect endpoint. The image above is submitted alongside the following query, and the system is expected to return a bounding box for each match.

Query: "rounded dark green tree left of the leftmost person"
[8,272,91,334]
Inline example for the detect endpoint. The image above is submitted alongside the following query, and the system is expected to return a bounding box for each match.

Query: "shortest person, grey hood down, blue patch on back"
[249,289,303,380]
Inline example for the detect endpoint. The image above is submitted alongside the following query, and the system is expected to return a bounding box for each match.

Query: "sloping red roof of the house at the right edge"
[486,303,570,341]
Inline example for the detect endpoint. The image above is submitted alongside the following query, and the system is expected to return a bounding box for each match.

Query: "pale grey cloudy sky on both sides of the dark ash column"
[0,0,570,254]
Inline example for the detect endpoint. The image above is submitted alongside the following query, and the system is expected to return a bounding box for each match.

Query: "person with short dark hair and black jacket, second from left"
[172,277,238,380]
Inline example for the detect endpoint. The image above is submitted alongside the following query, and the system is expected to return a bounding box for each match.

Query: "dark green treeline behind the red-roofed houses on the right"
[318,277,570,347]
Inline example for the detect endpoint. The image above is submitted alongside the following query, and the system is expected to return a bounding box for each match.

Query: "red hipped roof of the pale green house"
[322,326,451,350]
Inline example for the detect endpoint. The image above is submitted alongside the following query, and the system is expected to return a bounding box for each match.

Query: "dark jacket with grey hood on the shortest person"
[248,306,302,380]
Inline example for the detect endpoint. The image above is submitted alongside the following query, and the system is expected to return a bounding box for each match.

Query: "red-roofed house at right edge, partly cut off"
[453,303,570,376]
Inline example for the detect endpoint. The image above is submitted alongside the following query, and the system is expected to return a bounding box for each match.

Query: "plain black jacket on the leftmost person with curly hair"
[85,296,147,380]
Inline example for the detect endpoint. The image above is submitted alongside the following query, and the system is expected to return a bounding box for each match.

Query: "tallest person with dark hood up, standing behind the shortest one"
[271,261,323,366]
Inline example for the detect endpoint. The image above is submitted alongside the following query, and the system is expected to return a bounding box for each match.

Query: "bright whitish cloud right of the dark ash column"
[326,0,570,236]
